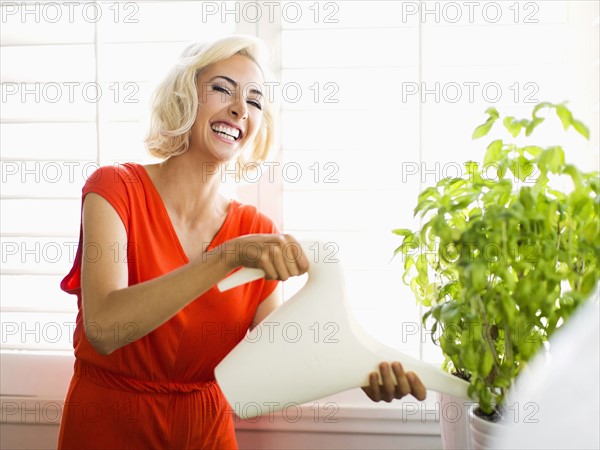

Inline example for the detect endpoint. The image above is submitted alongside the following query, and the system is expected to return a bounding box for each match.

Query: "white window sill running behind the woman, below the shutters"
[0,351,440,436]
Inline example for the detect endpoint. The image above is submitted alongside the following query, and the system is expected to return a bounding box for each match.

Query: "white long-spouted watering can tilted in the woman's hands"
[215,242,469,419]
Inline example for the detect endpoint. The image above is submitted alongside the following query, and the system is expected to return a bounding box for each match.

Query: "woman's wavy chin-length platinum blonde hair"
[144,35,275,164]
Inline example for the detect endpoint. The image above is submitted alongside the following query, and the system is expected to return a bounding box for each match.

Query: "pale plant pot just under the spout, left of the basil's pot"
[438,393,472,450]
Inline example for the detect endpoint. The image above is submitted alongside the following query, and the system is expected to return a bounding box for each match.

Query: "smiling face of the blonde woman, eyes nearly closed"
[190,55,264,163]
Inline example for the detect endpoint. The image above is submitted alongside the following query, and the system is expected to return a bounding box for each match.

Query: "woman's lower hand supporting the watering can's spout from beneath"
[362,361,427,403]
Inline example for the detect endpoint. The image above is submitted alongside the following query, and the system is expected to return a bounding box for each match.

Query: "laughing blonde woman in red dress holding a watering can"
[59,36,425,449]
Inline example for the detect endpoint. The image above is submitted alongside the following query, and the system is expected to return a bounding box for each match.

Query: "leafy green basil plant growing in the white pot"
[393,102,600,415]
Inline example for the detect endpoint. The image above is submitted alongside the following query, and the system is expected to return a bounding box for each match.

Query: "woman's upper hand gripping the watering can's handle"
[215,234,309,281]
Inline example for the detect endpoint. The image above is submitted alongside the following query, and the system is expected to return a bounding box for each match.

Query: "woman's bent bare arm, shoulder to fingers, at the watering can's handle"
[81,193,308,354]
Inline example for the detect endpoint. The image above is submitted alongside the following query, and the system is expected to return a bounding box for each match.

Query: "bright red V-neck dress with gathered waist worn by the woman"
[58,163,277,450]
